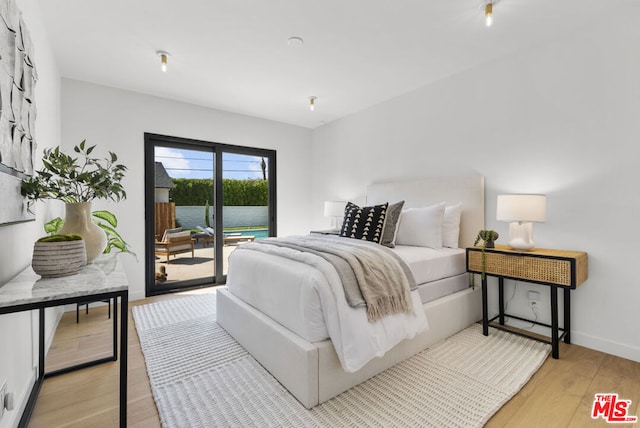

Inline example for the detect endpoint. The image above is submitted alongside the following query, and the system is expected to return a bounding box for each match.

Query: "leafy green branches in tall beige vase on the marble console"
[21,140,127,263]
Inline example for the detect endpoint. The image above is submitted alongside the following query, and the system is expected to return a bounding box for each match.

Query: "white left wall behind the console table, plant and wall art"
[0,0,61,428]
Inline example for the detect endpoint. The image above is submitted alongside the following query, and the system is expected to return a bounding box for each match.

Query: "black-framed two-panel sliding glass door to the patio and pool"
[145,134,276,296]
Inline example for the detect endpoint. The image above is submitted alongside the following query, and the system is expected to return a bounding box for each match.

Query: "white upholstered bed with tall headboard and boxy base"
[217,176,484,408]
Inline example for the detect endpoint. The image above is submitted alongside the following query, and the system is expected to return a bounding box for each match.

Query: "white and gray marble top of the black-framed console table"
[0,254,129,308]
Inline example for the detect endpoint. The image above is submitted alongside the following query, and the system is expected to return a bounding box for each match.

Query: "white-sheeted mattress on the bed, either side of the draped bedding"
[227,246,468,342]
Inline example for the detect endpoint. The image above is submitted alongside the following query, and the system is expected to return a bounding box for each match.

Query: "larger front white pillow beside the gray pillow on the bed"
[396,202,445,248]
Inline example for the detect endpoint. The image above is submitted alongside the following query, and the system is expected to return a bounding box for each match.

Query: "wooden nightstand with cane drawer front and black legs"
[467,245,588,359]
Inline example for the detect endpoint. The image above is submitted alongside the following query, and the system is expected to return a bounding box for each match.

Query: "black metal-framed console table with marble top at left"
[0,254,129,427]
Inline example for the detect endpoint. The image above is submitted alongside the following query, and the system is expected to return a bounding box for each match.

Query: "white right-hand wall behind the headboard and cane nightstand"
[312,5,640,361]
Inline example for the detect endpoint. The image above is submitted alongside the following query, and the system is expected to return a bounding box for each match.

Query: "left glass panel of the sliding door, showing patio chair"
[154,145,216,288]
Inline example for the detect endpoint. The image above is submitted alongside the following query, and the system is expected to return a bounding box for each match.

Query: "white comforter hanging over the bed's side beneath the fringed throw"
[227,238,428,372]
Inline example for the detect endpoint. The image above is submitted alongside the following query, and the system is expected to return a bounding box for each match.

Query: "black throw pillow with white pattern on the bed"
[340,202,389,243]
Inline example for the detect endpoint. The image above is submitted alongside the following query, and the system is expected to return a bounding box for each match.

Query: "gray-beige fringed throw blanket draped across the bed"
[252,235,417,322]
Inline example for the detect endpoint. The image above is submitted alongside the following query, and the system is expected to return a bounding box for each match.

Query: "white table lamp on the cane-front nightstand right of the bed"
[496,194,547,250]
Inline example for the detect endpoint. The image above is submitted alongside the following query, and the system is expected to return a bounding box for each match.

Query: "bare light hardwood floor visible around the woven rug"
[29,295,640,428]
